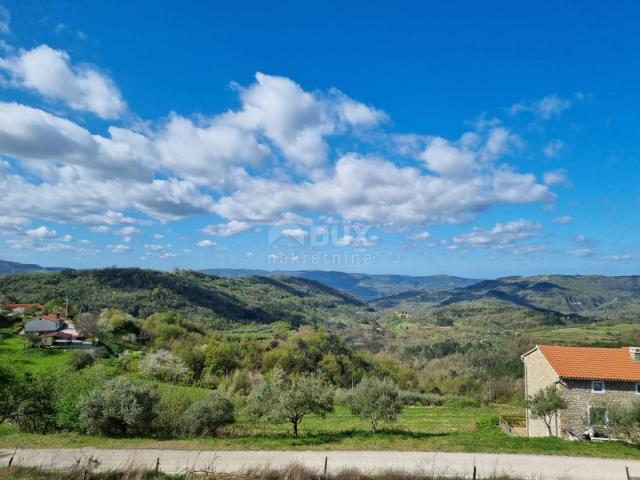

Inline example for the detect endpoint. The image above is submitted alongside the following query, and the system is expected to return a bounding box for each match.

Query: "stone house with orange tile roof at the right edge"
[521,345,640,438]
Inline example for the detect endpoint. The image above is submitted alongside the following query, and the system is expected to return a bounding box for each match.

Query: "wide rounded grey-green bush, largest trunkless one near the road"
[79,377,159,436]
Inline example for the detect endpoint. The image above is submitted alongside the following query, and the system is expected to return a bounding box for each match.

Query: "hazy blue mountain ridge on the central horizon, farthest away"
[201,268,482,301]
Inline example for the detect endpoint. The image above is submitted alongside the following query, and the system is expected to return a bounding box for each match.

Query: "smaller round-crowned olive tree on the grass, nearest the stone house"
[347,377,402,433]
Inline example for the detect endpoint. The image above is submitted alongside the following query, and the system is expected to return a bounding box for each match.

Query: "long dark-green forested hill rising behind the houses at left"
[0,268,368,324]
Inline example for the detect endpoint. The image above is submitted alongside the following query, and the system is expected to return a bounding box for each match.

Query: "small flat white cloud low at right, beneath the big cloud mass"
[453,219,544,253]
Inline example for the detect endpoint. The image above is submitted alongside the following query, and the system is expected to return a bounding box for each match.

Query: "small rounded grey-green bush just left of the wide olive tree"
[182,392,234,436]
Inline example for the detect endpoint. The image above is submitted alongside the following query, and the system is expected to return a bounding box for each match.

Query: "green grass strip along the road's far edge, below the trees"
[0,406,640,459]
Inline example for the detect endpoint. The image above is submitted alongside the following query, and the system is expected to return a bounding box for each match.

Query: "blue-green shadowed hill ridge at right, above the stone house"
[372,275,640,320]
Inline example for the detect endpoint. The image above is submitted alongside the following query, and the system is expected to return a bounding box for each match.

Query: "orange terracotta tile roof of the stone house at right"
[538,345,640,382]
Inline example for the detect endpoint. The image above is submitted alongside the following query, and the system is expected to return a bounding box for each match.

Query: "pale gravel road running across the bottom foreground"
[0,448,640,480]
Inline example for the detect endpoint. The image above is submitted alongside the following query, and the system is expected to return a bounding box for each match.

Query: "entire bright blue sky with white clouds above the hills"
[0,0,640,278]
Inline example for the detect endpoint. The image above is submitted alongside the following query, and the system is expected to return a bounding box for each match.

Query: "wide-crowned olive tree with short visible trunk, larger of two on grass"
[247,369,333,437]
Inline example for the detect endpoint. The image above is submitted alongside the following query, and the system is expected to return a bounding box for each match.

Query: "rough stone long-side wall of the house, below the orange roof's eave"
[560,380,640,435]
